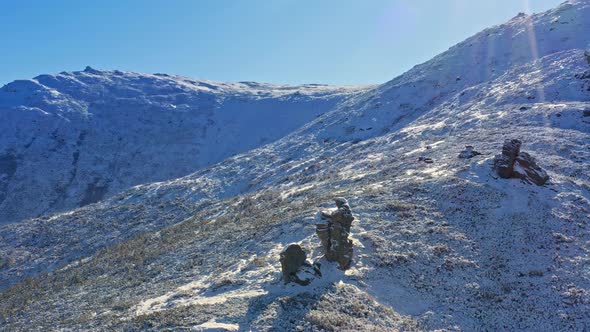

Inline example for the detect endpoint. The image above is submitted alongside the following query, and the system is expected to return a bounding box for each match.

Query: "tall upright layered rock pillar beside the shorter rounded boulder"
[316,198,354,270]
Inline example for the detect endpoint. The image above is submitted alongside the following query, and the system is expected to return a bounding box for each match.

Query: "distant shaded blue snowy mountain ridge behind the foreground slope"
[0,68,366,224]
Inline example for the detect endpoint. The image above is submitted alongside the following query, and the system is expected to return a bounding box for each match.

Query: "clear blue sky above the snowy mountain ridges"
[0,0,562,85]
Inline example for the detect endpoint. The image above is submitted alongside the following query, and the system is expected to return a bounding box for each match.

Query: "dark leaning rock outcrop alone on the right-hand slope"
[494,139,549,186]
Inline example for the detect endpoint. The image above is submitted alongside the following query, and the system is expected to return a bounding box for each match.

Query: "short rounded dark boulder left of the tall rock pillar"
[280,243,322,286]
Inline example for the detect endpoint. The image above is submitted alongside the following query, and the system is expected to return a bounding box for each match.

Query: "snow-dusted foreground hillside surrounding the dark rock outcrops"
[0,1,590,331]
